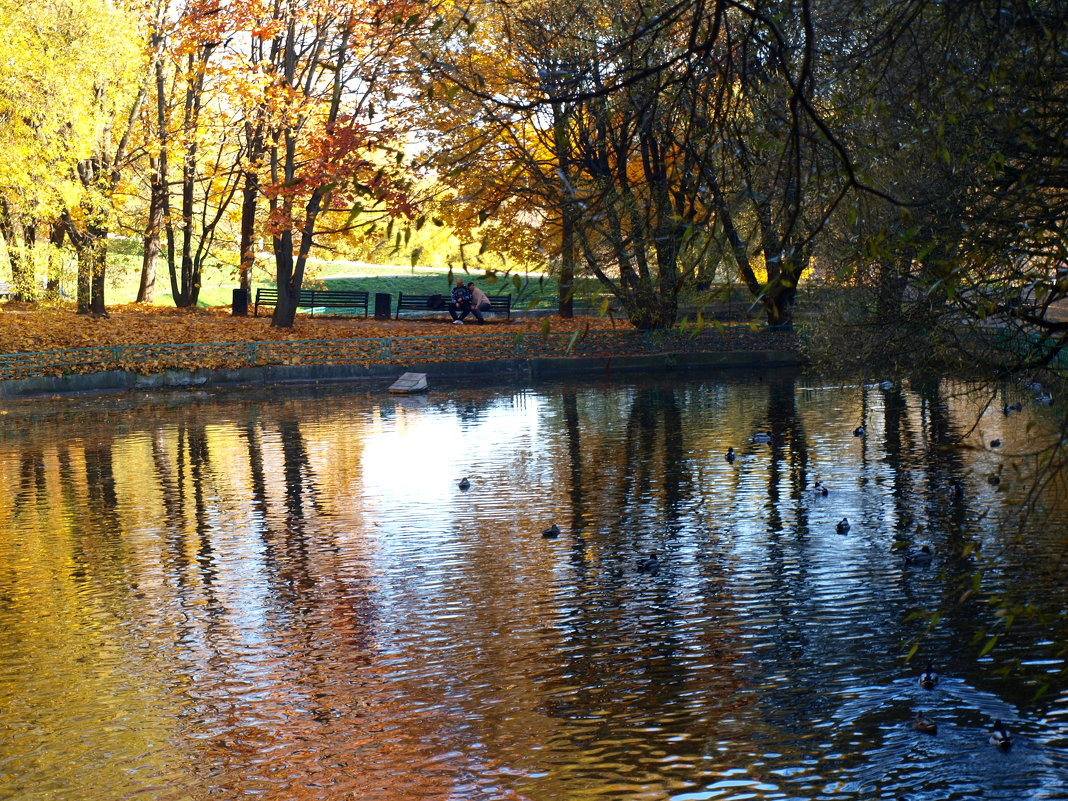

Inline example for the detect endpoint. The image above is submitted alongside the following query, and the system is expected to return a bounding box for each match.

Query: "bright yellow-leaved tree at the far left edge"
[0,0,139,309]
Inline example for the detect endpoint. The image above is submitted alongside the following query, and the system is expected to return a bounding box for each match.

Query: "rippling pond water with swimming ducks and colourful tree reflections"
[0,372,1068,801]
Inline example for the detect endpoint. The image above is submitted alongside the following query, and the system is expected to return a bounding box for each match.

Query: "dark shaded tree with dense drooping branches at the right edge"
[807,2,1068,367]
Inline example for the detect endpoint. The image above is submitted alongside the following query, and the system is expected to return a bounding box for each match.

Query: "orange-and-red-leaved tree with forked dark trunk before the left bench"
[244,0,412,328]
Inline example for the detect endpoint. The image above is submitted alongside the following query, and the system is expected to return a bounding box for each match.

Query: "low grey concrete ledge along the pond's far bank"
[0,350,801,398]
